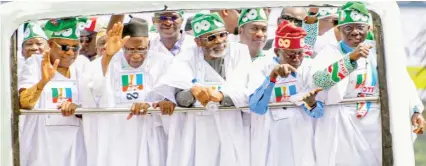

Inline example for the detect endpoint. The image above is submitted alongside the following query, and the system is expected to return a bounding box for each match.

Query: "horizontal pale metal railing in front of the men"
[21,97,380,115]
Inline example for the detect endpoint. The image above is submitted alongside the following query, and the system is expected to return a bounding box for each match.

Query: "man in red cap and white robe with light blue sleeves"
[248,21,323,166]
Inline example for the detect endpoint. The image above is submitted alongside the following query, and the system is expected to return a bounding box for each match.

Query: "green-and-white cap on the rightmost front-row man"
[337,2,370,26]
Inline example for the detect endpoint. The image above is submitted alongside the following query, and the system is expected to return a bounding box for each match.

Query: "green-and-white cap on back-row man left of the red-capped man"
[238,8,268,27]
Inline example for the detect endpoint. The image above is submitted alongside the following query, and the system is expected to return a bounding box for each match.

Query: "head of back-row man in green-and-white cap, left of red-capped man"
[238,8,268,61]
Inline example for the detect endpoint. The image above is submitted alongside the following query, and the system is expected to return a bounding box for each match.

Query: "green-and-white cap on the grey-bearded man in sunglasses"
[191,13,225,37]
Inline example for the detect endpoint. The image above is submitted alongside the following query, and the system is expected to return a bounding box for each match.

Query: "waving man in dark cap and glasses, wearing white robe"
[82,18,175,166]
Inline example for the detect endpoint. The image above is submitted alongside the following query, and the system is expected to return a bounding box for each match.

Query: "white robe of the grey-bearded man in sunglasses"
[155,42,251,166]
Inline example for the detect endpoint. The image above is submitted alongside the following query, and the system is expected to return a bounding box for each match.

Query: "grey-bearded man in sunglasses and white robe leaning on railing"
[155,13,251,166]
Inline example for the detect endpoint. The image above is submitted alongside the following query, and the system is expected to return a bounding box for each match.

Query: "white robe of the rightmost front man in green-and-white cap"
[310,43,382,166]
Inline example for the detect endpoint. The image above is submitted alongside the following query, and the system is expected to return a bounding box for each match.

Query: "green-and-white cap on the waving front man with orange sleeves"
[44,17,87,40]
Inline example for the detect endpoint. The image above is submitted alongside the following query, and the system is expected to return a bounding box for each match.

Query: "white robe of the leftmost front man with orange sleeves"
[19,55,89,166]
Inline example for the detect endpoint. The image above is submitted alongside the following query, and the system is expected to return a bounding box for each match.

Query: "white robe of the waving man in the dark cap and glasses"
[82,51,173,166]
